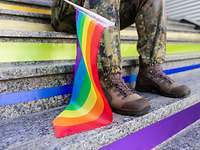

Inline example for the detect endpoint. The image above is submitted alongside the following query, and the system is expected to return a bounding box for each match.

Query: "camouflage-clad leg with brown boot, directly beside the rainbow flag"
[85,0,150,115]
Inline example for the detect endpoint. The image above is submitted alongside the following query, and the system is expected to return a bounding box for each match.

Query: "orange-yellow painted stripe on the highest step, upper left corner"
[0,2,51,15]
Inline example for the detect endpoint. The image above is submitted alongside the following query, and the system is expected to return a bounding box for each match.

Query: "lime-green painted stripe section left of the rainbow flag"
[0,42,76,62]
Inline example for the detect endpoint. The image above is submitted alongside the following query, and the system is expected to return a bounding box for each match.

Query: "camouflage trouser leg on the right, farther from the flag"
[135,0,166,64]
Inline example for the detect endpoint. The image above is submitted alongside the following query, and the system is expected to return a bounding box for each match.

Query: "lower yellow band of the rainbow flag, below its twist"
[58,86,97,118]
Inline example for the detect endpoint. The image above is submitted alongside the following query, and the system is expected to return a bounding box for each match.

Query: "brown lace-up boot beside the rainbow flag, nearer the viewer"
[101,69,150,116]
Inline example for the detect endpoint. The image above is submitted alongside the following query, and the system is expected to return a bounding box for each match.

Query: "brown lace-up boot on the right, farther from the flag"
[135,58,191,98]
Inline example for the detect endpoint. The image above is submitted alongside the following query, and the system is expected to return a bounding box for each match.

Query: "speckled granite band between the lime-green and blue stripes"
[0,59,200,94]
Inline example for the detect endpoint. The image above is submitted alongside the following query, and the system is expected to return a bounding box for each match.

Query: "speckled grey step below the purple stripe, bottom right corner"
[155,120,200,150]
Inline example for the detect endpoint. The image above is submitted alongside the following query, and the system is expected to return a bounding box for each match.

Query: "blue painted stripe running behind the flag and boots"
[0,64,200,106]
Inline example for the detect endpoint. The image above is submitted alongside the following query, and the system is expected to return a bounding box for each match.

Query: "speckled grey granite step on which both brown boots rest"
[0,69,200,150]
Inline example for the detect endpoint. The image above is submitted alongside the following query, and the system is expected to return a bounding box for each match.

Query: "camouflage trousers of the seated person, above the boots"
[52,0,166,72]
